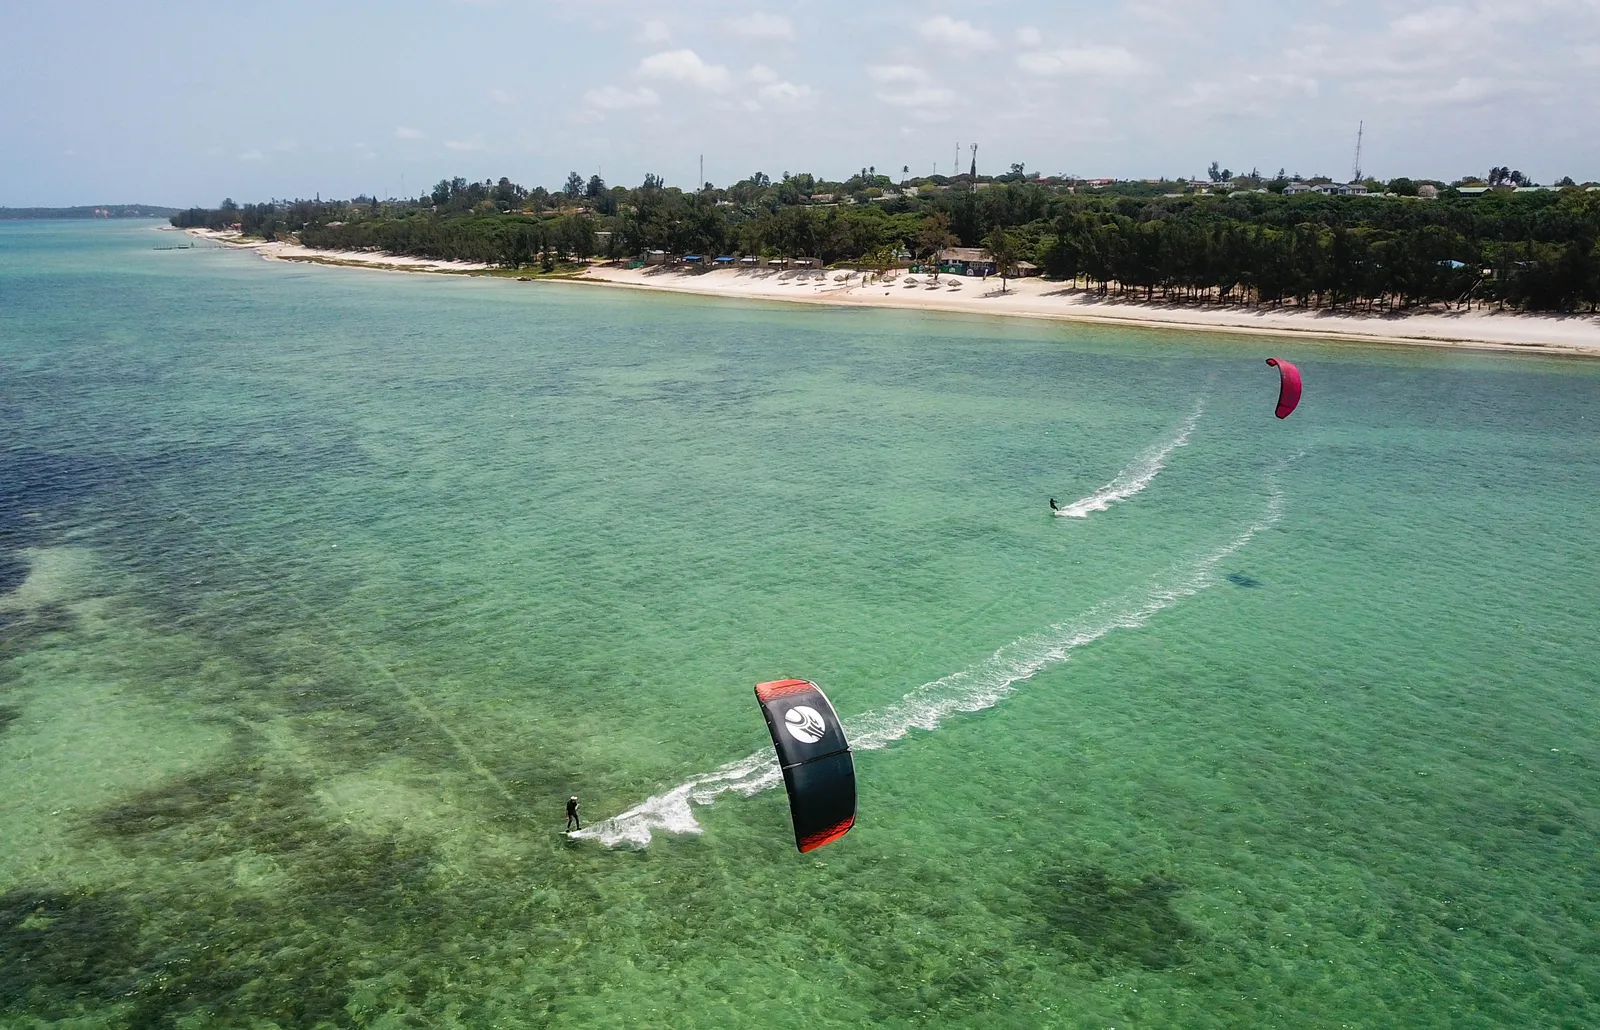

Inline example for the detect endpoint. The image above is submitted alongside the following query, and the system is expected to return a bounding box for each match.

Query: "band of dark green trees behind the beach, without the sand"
[171,165,1600,310]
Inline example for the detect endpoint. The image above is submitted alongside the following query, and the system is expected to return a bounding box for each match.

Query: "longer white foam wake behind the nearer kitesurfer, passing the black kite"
[573,486,1283,848]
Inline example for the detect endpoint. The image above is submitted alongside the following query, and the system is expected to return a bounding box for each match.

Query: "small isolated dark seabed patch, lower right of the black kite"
[1032,867,1200,972]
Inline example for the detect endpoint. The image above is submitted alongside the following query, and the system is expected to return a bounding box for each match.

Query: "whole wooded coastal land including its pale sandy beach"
[171,165,1600,353]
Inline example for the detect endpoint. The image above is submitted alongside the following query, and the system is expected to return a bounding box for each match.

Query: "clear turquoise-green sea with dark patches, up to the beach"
[0,222,1600,1028]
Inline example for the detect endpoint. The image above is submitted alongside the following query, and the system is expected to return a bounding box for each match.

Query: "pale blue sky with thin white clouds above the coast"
[0,0,1600,206]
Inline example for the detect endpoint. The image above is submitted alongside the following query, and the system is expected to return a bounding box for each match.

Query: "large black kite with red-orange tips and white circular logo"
[755,680,856,851]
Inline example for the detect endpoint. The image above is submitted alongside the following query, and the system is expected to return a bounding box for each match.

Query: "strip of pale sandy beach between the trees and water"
[189,229,1600,357]
